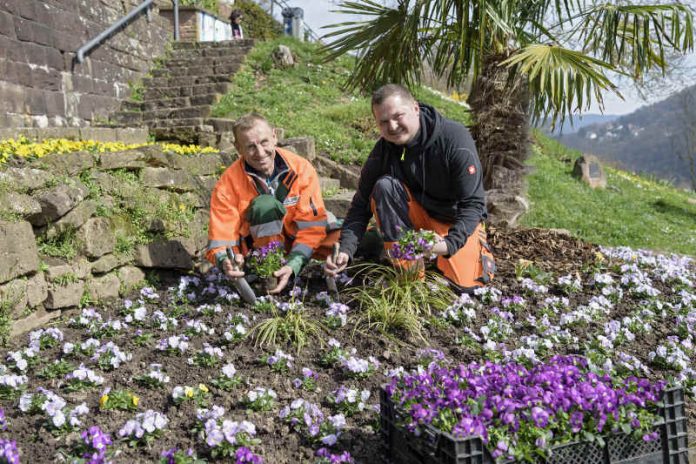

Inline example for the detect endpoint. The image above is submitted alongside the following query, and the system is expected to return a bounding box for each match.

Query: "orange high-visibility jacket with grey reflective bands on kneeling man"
[206,148,327,264]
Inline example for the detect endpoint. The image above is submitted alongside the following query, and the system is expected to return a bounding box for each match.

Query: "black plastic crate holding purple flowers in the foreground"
[380,388,689,464]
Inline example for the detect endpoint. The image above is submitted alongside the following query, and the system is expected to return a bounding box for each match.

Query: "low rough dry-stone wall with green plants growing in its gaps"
[0,146,232,333]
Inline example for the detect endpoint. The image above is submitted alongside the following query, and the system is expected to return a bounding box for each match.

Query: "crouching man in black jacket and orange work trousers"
[326,84,495,288]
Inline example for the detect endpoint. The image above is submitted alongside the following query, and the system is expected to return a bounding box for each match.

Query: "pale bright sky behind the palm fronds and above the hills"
[262,0,696,115]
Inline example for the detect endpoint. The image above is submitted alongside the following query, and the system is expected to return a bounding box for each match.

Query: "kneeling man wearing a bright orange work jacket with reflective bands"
[206,113,339,293]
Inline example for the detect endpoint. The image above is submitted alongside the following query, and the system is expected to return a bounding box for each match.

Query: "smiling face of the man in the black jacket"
[372,95,420,145]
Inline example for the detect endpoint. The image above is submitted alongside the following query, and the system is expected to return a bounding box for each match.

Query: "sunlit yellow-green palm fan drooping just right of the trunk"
[502,44,621,125]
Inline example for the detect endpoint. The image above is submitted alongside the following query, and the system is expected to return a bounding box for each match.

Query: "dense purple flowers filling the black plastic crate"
[386,356,664,457]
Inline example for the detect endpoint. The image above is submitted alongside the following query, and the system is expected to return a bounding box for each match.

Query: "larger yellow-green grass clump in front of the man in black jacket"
[346,263,456,338]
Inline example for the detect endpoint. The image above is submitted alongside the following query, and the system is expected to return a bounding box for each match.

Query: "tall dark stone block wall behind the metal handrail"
[0,0,173,127]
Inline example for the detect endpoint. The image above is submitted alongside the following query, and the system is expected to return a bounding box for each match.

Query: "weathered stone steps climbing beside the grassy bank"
[111,39,254,148]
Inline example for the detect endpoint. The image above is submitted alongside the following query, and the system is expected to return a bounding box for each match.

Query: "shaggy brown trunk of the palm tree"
[468,54,530,194]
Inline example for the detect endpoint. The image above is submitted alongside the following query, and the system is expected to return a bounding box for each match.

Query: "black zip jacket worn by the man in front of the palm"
[341,103,487,258]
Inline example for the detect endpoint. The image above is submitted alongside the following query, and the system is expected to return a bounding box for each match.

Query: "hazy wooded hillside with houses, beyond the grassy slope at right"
[556,86,696,187]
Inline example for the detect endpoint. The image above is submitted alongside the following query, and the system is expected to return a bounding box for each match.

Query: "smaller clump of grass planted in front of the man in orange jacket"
[249,301,321,353]
